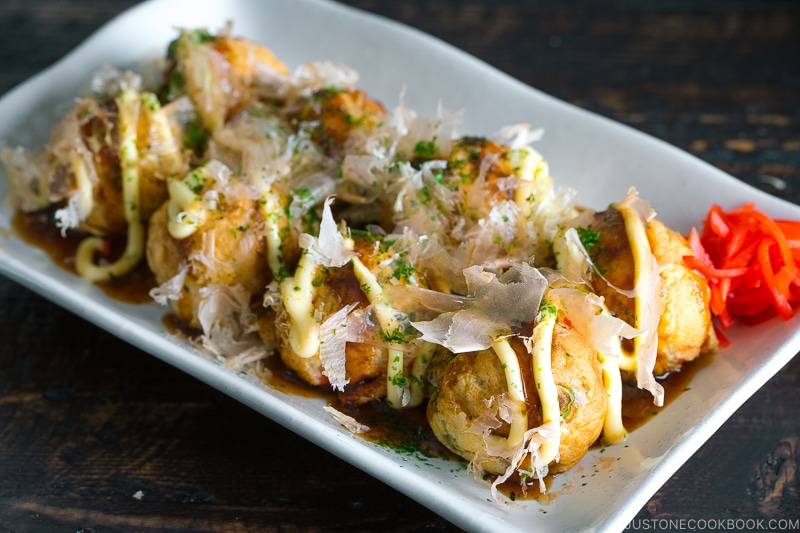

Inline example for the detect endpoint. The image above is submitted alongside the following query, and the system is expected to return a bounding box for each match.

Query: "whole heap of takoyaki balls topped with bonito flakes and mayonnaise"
[2,28,717,501]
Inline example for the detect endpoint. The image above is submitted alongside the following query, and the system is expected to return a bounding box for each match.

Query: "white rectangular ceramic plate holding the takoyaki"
[0,0,800,532]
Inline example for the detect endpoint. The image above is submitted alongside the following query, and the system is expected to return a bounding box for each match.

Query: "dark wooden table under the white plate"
[0,0,800,532]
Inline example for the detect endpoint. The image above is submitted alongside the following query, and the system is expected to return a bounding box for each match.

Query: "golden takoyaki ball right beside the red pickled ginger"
[584,208,718,376]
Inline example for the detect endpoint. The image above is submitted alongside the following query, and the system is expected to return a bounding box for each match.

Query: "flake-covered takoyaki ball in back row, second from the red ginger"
[390,137,577,272]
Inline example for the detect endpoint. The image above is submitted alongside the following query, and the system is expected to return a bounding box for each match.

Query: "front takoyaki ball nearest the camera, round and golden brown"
[427,313,608,474]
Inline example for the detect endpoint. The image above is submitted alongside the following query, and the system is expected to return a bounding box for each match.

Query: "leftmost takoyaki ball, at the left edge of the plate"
[5,92,185,238]
